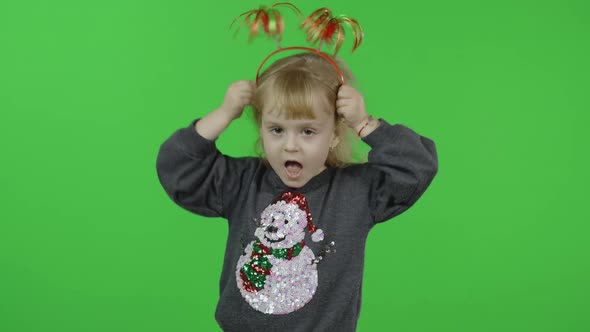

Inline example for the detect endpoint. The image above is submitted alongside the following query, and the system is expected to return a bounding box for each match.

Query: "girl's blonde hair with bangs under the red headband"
[252,52,354,167]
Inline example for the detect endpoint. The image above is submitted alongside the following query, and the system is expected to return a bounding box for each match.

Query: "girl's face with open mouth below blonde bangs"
[260,98,339,188]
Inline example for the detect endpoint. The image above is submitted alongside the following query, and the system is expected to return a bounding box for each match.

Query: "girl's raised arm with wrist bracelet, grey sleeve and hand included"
[336,85,438,222]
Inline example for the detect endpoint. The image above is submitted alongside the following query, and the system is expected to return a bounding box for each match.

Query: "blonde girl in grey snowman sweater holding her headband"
[157,52,438,331]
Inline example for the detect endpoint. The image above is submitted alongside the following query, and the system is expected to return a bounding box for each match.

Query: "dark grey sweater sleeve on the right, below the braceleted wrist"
[363,119,438,223]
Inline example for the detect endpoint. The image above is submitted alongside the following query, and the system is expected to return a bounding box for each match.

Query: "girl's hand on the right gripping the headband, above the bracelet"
[336,84,369,132]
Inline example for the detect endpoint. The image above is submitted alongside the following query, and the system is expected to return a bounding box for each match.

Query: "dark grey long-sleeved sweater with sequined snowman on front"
[157,119,438,331]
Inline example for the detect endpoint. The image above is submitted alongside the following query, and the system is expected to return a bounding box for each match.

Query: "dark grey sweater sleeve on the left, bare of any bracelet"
[156,119,258,218]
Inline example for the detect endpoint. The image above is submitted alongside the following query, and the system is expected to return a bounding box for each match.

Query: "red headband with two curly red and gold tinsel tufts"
[230,2,364,84]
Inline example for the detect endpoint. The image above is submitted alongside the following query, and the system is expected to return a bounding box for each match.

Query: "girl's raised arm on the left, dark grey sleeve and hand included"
[156,81,257,217]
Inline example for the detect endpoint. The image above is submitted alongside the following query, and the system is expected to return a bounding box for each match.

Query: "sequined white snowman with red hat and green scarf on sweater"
[236,191,324,314]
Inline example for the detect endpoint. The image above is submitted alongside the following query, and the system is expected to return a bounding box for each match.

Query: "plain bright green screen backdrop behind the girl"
[0,0,590,332]
